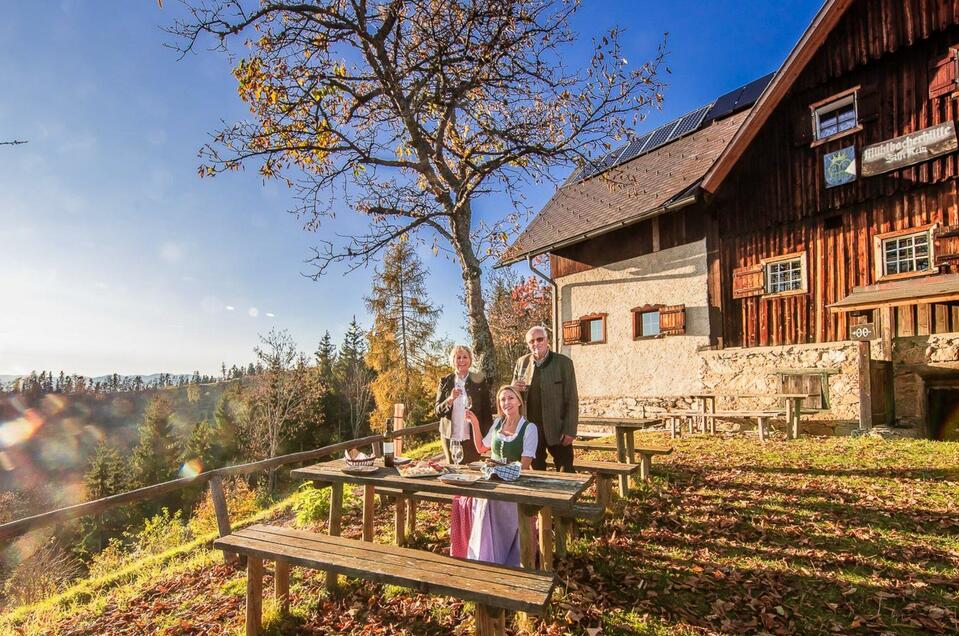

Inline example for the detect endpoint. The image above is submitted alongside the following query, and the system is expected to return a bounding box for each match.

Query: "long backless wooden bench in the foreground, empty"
[213,525,556,636]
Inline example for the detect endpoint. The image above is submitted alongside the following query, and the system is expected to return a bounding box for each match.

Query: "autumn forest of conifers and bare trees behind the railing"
[0,241,551,608]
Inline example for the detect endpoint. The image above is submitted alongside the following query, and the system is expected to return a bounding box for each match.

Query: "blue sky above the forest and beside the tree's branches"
[0,0,821,375]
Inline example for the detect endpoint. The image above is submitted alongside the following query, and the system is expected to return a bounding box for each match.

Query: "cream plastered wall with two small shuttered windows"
[557,240,709,402]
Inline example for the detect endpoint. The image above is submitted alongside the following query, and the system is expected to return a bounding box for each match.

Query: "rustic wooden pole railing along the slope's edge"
[0,422,439,542]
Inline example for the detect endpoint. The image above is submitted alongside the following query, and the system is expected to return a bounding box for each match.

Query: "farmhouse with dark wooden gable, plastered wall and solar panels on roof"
[502,0,959,439]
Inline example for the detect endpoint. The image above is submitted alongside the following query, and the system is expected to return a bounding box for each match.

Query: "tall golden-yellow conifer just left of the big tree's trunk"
[366,241,441,430]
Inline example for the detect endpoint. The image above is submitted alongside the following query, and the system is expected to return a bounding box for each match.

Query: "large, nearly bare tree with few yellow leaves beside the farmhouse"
[170,0,665,377]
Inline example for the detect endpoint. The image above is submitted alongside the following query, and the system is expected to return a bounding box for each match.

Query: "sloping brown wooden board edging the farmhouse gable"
[702,0,854,193]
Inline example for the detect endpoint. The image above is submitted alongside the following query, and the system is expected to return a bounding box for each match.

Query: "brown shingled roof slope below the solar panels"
[499,111,749,265]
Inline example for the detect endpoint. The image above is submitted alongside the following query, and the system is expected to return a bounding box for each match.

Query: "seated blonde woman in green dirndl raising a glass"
[467,384,539,567]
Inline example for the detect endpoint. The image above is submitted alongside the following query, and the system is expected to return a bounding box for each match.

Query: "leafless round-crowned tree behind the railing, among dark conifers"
[246,329,310,492]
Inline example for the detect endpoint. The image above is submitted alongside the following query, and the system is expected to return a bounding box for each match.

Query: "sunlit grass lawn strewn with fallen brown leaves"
[0,437,959,636]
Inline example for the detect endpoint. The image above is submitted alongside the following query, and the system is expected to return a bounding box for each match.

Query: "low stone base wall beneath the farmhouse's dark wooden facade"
[700,342,859,434]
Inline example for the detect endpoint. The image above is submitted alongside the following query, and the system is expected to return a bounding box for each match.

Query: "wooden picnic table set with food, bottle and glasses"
[290,459,593,570]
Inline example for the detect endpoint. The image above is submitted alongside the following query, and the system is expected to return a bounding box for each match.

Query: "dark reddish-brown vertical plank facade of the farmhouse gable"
[707,0,959,346]
